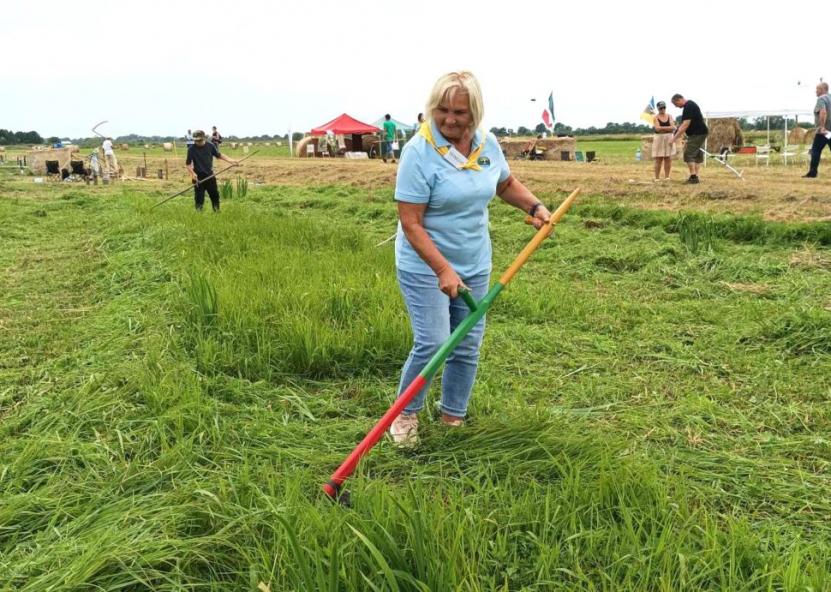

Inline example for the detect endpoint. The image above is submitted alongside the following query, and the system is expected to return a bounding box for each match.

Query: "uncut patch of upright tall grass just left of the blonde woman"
[176,208,409,380]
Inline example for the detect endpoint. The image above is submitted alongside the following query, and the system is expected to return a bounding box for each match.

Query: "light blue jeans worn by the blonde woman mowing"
[398,269,490,417]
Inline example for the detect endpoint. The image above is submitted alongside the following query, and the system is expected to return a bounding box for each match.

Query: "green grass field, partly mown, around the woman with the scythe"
[0,175,831,592]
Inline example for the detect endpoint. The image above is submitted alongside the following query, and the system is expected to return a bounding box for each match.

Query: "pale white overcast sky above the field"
[0,0,831,137]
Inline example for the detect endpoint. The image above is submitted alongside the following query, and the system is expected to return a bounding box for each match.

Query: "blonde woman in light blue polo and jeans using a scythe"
[390,72,551,445]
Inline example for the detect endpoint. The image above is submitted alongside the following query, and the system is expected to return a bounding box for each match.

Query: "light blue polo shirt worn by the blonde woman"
[395,121,511,279]
